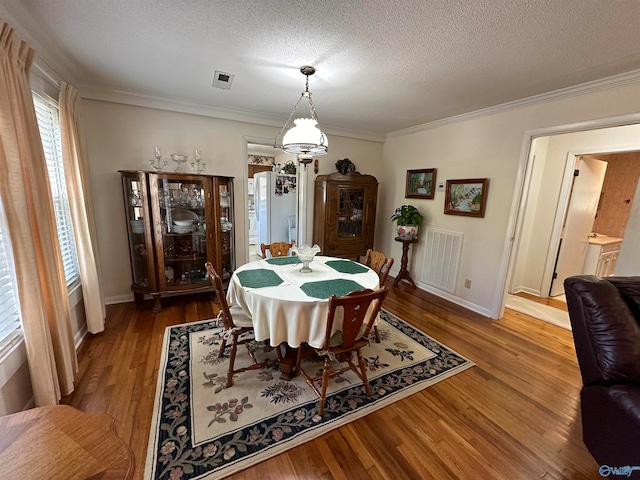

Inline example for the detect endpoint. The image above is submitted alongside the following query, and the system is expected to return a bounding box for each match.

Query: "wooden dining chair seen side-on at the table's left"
[205,262,281,388]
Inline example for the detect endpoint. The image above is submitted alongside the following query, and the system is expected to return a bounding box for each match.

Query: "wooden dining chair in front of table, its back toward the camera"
[296,287,389,415]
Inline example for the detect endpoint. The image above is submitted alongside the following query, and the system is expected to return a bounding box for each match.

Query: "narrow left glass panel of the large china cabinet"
[122,172,156,291]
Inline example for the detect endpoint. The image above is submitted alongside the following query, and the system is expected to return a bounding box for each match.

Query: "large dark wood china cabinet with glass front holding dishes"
[120,170,235,313]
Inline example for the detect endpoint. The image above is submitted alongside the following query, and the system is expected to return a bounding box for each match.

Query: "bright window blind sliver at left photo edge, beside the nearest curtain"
[0,204,21,352]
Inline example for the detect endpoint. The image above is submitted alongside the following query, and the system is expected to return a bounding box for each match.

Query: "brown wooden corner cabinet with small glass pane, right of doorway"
[313,172,378,258]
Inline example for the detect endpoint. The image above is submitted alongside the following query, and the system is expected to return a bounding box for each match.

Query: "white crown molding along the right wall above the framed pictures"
[386,70,640,138]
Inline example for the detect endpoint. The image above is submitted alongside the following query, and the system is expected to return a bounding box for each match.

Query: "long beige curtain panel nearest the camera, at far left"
[0,19,78,406]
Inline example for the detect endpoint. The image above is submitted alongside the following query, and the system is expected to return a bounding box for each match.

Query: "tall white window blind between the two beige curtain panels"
[33,93,79,287]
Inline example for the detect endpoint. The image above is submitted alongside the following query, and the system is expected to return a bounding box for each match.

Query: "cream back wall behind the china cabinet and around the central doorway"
[77,100,382,303]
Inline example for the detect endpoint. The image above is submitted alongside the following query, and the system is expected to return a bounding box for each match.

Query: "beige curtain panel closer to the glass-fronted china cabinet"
[58,82,106,333]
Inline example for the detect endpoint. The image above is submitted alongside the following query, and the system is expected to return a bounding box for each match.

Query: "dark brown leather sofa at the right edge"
[564,275,640,466]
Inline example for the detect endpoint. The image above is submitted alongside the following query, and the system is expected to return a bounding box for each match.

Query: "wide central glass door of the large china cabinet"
[150,174,212,290]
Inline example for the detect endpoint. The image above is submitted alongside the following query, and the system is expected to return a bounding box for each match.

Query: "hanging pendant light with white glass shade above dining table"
[273,66,329,161]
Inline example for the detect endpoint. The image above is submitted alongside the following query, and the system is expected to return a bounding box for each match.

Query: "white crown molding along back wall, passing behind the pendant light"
[81,85,386,142]
